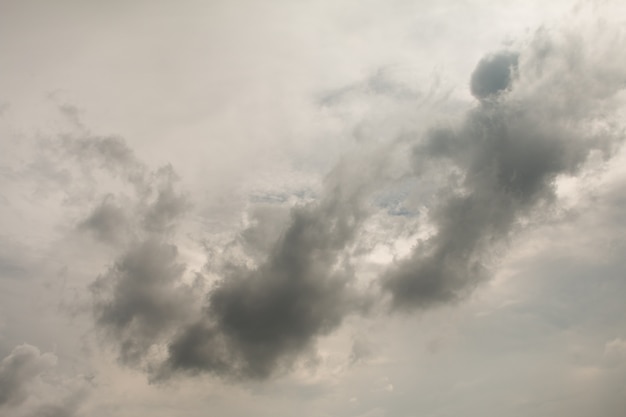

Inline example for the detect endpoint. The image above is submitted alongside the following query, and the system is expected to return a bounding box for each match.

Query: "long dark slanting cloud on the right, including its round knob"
[382,38,626,309]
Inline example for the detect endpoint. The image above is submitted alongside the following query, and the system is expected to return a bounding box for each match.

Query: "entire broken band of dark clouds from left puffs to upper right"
[74,16,626,380]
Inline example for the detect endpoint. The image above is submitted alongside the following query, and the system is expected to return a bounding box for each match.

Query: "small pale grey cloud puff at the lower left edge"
[0,344,56,409]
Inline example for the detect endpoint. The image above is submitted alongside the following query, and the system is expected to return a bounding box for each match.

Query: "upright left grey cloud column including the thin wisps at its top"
[64,136,190,367]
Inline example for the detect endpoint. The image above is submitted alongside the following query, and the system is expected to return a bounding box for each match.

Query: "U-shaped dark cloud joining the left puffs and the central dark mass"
[80,134,387,379]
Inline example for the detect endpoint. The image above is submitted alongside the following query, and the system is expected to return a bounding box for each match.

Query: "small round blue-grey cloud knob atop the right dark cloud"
[470,52,518,99]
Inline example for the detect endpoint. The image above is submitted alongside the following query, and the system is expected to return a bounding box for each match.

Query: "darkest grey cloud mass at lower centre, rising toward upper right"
[170,205,354,377]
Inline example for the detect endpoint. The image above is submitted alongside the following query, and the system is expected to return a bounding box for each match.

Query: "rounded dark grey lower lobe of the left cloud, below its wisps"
[90,239,191,365]
